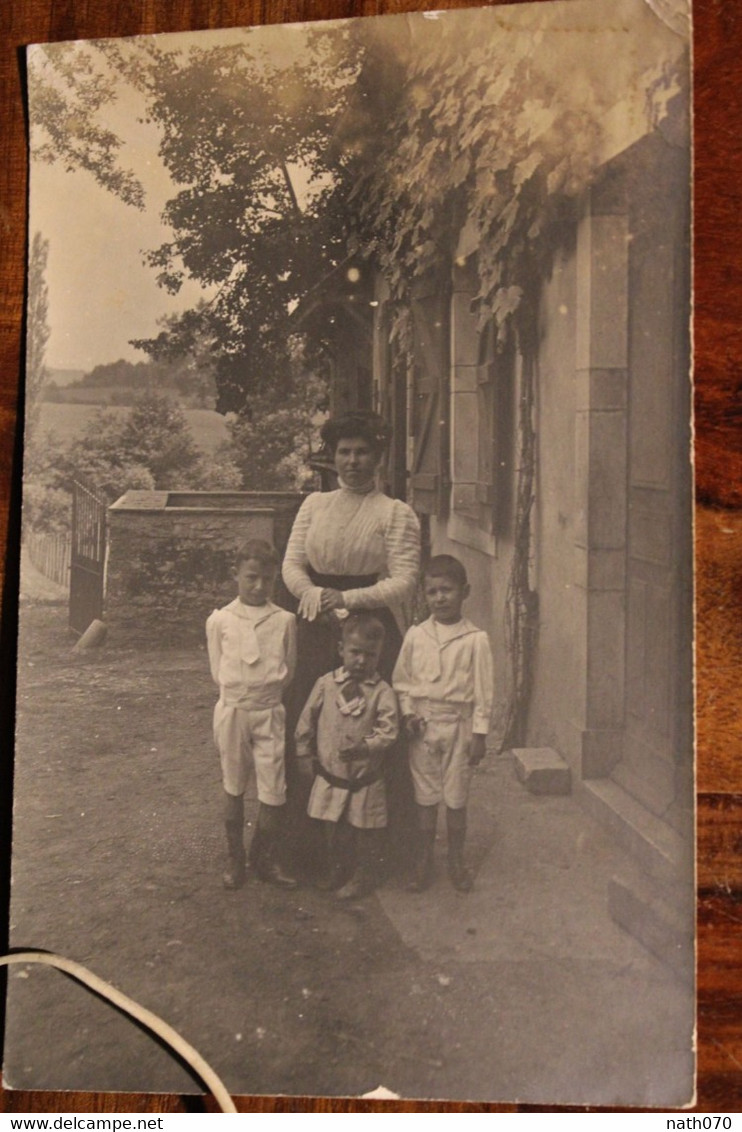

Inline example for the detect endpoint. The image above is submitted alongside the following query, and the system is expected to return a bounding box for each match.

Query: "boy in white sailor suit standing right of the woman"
[392,555,494,892]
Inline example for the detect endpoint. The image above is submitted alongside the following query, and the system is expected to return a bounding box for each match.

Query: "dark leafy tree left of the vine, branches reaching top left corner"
[29,28,362,412]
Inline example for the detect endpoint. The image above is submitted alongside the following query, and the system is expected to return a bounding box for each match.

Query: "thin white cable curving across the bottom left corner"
[0,951,237,1113]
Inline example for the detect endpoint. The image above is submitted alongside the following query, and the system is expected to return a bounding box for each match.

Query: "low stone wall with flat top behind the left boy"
[104,491,302,648]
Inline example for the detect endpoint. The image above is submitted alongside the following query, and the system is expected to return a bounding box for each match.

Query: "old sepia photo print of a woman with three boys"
[3,0,694,1108]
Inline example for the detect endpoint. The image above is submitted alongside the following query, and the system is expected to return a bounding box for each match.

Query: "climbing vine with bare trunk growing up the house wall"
[350,6,686,747]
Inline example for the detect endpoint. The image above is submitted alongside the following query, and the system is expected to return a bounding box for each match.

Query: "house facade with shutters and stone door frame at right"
[321,82,693,967]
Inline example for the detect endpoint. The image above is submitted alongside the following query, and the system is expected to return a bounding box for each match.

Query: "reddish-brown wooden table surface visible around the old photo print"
[0,0,742,1113]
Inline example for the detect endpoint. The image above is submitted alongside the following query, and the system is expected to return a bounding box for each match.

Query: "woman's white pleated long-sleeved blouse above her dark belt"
[282,487,420,616]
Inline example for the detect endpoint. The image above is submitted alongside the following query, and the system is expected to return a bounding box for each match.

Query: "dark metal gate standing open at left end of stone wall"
[69,480,108,636]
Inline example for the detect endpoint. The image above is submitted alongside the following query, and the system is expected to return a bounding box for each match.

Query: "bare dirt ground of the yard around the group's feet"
[6,601,692,1104]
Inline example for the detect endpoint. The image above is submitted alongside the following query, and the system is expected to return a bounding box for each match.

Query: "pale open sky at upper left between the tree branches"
[28,25,321,371]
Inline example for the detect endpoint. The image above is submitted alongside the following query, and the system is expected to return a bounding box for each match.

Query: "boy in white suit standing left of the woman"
[206,539,297,889]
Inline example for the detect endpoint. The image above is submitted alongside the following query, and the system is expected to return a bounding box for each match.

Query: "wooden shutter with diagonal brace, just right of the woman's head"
[410,277,450,515]
